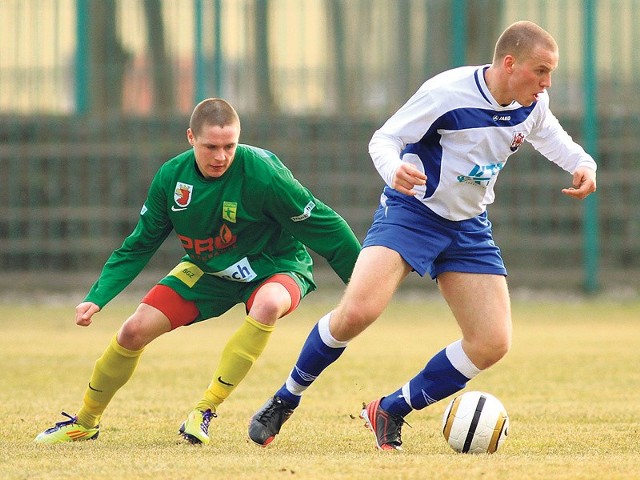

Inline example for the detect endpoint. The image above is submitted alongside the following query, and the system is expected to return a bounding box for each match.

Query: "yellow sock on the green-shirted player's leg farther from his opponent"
[78,335,144,428]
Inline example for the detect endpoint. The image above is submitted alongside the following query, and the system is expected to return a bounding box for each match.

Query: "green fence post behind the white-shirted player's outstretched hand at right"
[582,0,600,293]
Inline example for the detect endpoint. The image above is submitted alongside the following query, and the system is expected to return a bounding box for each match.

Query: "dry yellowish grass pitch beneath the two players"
[0,300,640,479]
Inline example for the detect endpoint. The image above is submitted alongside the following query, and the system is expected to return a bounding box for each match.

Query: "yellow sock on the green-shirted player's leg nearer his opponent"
[196,315,275,412]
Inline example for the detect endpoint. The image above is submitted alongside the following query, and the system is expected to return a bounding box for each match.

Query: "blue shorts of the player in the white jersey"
[362,193,507,279]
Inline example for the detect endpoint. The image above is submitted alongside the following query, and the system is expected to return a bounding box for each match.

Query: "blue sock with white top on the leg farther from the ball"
[276,313,347,408]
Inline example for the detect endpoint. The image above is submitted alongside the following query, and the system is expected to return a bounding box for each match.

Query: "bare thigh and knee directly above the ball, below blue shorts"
[438,272,512,367]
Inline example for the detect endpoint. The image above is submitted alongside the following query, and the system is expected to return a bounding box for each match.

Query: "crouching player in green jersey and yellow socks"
[35,98,360,444]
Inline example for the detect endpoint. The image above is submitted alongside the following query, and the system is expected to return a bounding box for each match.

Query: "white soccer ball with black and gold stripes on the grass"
[442,392,509,453]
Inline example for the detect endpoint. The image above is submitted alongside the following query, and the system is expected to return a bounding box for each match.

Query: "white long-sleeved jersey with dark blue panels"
[369,65,596,221]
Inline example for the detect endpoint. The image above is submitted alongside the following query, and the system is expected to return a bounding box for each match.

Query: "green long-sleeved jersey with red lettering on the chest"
[85,145,360,308]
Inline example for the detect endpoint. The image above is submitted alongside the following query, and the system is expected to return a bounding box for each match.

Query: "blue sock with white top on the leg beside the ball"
[380,342,480,416]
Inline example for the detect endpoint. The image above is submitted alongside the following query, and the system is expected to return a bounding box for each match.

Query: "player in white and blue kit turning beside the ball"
[249,21,596,450]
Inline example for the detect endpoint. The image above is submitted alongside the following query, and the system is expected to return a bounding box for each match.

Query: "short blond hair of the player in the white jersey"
[493,20,558,64]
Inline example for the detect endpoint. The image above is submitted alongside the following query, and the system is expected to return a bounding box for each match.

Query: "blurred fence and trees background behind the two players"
[0,0,640,296]
